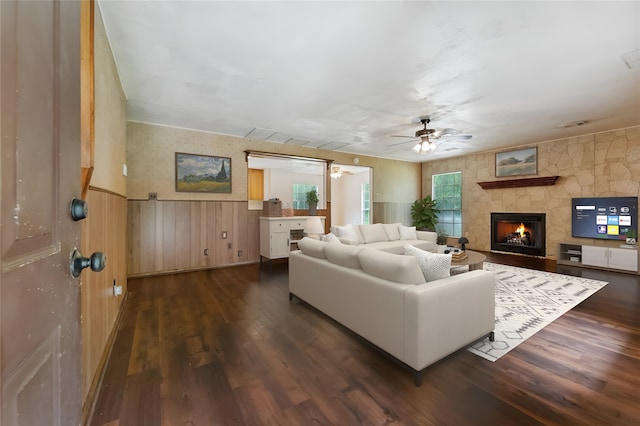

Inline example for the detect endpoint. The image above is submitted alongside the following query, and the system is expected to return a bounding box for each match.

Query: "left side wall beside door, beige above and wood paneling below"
[81,7,127,413]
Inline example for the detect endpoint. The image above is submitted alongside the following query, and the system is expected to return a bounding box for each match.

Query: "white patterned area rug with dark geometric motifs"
[467,262,608,362]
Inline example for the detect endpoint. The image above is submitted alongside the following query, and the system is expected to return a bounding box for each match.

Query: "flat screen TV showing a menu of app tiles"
[571,197,638,240]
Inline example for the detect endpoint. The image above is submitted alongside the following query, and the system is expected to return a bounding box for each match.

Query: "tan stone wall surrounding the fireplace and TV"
[422,126,640,258]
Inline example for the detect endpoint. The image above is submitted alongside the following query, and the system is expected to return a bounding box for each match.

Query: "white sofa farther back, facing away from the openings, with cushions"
[330,223,438,254]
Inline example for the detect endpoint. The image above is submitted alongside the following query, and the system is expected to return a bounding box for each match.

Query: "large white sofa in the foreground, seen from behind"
[289,238,495,386]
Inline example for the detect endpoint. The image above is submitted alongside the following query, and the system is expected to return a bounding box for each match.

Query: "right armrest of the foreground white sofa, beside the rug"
[404,270,496,370]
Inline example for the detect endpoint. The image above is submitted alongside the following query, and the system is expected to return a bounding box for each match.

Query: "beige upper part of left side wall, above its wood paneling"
[91,3,127,196]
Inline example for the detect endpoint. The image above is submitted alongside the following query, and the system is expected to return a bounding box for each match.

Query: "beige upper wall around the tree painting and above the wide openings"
[127,122,421,207]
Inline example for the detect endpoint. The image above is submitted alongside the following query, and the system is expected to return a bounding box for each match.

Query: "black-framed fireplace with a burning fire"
[491,213,547,257]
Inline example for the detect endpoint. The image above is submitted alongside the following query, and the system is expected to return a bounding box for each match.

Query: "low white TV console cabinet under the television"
[556,243,639,274]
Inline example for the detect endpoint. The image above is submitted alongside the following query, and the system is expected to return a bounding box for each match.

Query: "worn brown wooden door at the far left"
[0,0,86,426]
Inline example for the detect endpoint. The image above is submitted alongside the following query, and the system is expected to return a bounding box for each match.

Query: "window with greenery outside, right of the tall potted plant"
[431,172,462,236]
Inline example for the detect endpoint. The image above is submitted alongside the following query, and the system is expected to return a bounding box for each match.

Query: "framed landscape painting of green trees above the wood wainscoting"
[176,152,231,194]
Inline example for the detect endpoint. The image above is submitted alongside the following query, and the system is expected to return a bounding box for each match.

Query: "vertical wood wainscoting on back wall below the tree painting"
[127,200,262,276]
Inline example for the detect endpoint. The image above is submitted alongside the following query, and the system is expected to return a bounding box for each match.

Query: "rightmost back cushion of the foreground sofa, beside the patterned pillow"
[358,249,425,285]
